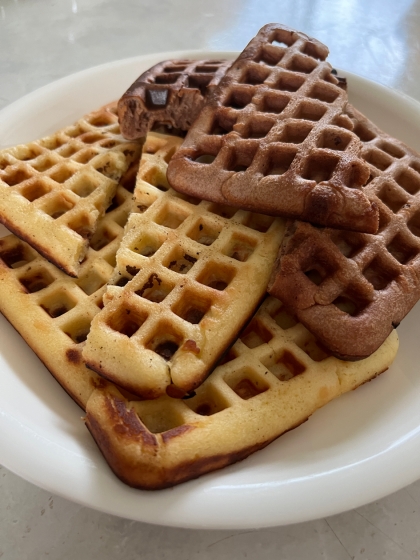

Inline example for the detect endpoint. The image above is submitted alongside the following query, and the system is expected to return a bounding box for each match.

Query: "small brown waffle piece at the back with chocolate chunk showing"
[118,60,231,140]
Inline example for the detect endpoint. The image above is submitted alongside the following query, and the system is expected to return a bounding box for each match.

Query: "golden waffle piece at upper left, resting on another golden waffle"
[0,103,141,276]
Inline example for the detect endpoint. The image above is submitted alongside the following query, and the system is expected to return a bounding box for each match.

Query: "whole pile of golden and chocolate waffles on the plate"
[0,20,420,489]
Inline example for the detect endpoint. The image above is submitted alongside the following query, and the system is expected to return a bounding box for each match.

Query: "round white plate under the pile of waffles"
[0,52,420,529]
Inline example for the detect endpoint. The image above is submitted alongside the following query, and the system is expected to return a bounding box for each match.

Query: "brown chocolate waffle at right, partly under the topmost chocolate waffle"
[270,107,420,360]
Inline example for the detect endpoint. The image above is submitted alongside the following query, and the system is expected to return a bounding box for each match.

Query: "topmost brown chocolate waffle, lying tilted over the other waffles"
[168,24,378,233]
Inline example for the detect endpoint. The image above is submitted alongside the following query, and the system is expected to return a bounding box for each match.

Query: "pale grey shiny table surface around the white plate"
[0,0,420,560]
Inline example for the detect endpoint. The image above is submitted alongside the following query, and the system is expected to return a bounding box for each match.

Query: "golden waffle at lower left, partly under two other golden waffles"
[0,158,135,408]
